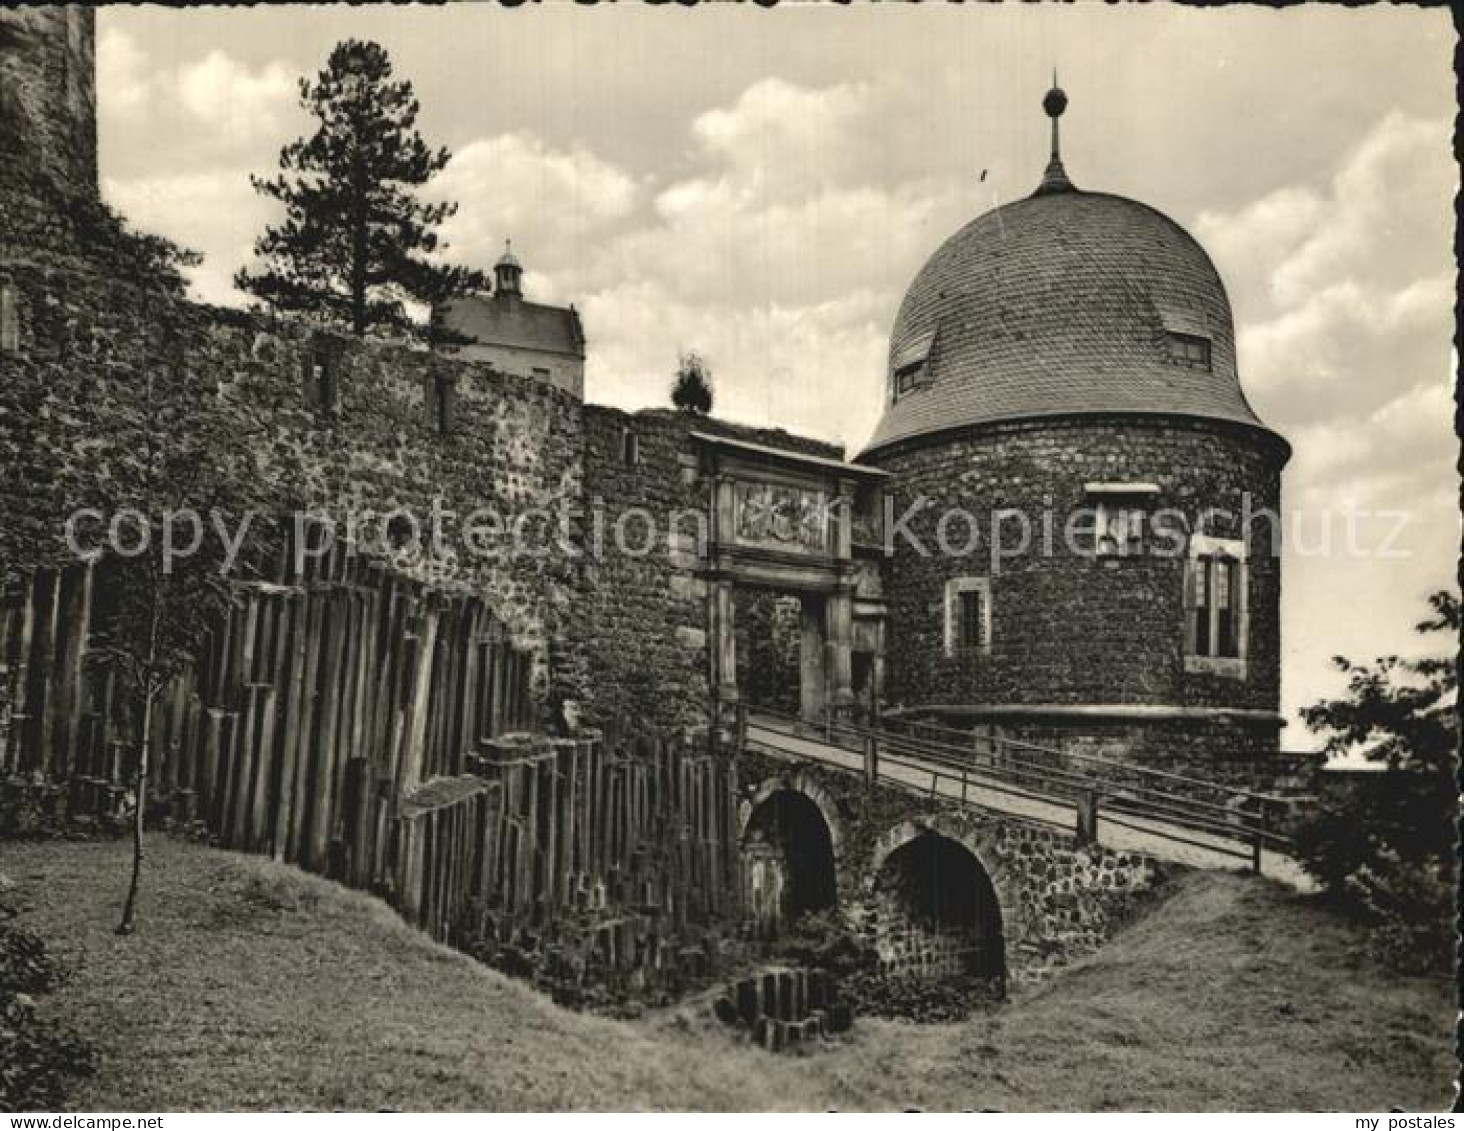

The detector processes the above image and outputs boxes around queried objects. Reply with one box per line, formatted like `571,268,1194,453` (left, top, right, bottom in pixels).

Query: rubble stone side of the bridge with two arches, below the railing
738,745,1173,982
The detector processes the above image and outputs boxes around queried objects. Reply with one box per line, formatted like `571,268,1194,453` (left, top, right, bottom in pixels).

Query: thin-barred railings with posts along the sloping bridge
739,708,1291,871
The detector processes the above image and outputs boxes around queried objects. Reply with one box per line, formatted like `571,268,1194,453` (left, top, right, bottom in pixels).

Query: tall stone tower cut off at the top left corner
0,4,97,196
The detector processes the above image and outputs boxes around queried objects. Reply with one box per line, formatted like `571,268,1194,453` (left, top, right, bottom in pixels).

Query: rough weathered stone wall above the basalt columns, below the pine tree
0,253,581,705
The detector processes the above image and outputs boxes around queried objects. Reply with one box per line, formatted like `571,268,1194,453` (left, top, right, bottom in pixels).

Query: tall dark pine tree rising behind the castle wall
234,40,486,335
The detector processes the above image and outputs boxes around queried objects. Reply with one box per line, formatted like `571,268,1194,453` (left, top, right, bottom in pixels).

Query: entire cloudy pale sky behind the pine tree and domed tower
98,3,1458,748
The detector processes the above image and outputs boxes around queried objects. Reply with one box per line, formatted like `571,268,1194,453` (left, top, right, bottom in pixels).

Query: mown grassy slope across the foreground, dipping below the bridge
0,840,1454,1111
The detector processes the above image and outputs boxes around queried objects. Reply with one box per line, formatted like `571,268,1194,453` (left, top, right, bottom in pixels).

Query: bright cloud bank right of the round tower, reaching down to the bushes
1196,113,1460,722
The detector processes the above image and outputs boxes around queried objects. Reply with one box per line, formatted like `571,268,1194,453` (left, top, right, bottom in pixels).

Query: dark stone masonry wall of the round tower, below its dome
874,418,1284,749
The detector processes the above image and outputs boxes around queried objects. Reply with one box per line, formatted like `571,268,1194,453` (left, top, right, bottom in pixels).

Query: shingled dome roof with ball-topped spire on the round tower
864,83,1282,455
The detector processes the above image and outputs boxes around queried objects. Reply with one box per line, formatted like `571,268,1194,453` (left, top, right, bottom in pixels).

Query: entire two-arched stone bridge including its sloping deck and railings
738,714,1306,980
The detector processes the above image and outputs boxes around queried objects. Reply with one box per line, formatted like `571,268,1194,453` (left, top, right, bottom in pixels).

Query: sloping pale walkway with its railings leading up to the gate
738,708,1313,890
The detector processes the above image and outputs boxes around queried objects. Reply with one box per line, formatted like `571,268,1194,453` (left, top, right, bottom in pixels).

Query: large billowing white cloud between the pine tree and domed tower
418,69,979,446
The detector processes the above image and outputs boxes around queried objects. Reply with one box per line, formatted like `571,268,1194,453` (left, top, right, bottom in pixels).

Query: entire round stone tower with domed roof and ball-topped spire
859,86,1290,771
